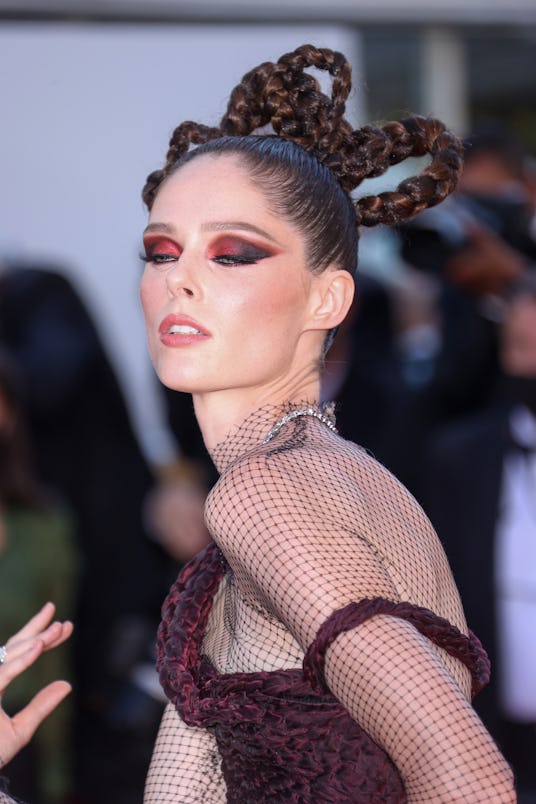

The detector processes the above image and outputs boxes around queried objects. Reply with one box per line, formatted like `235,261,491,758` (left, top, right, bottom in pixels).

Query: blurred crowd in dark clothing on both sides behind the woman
0,124,536,804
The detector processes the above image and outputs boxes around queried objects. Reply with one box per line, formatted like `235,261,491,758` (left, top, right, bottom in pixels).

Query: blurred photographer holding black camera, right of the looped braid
400,123,536,426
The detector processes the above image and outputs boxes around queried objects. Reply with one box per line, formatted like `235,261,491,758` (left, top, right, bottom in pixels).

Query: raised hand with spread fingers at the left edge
0,603,73,768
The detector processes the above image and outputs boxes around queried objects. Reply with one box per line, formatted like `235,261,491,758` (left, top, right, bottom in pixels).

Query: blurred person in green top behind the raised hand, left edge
0,350,78,804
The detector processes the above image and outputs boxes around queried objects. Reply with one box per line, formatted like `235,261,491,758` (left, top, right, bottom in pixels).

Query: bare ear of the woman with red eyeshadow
307,268,355,331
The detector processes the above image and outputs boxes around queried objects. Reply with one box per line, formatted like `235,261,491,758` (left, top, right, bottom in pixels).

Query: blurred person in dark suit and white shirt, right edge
420,276,536,803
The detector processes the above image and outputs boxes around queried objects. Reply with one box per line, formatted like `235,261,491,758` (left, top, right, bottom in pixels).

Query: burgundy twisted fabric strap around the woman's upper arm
303,597,490,696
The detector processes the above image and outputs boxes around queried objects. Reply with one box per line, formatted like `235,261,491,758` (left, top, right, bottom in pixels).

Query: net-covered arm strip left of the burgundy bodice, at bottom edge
143,704,227,804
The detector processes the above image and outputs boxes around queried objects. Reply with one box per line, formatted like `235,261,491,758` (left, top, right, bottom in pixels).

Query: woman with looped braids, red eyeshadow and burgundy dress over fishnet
141,45,514,804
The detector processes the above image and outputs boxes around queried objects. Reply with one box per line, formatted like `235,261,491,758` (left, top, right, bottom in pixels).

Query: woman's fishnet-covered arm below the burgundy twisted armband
325,616,516,804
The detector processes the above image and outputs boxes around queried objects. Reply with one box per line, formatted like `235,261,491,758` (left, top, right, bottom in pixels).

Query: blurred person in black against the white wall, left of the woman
0,264,167,804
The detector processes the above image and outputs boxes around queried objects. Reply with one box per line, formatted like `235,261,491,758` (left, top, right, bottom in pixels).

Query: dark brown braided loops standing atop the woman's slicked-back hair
143,45,461,231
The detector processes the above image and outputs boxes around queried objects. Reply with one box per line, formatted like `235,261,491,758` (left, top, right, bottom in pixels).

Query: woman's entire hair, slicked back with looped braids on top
143,45,462,284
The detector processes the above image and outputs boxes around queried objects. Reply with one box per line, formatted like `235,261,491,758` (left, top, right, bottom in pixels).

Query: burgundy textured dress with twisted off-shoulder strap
158,545,489,804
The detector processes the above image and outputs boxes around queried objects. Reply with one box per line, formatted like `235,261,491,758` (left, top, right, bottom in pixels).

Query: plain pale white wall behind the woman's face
0,23,361,459
